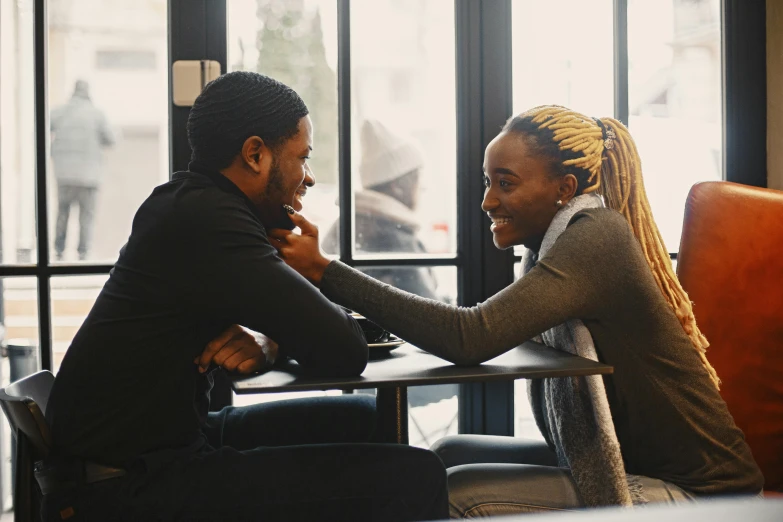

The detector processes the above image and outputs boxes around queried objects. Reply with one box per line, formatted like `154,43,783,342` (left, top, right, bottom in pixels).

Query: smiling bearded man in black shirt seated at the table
43,72,447,521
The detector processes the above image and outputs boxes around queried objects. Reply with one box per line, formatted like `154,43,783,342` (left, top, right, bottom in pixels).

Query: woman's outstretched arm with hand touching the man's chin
270,209,613,365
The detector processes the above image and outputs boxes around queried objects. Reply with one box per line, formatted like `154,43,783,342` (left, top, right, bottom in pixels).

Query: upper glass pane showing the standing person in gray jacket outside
47,0,169,262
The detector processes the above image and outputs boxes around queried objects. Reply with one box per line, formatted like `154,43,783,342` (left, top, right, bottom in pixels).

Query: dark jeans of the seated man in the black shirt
41,395,448,522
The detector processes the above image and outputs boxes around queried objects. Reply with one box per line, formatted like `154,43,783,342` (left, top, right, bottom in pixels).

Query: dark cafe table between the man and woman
232,341,613,444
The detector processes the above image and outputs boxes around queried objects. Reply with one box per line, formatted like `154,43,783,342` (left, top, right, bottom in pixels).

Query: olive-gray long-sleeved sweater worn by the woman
321,208,763,495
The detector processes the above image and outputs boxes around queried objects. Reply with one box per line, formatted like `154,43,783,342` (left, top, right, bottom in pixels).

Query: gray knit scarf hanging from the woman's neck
522,194,645,506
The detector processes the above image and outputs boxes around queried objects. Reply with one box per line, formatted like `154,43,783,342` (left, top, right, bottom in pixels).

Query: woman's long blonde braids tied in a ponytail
504,105,720,387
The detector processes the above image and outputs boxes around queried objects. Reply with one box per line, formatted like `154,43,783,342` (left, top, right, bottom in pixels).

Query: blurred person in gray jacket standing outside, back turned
51,80,114,261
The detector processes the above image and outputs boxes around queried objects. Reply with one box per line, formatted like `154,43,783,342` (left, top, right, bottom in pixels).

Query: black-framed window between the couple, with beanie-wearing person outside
227,0,458,445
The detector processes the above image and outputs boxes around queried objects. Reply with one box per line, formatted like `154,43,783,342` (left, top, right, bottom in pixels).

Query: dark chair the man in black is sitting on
0,370,54,522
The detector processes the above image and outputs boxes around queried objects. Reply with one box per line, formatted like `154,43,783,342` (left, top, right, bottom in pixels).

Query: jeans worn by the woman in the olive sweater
432,435,696,518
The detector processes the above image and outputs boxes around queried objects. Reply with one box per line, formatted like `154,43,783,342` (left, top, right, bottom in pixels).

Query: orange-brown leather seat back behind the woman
677,181,783,492
